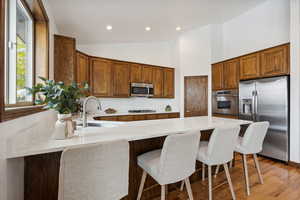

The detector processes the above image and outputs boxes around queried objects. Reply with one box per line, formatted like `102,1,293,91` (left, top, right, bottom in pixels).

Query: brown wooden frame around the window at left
0,0,50,122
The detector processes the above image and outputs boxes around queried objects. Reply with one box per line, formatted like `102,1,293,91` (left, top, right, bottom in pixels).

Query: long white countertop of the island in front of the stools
7,116,251,158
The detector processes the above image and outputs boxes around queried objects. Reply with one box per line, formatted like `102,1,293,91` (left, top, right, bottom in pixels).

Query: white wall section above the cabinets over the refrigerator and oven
213,0,290,62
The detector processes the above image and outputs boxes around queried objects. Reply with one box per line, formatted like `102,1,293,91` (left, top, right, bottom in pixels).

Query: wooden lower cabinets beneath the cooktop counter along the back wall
94,113,180,122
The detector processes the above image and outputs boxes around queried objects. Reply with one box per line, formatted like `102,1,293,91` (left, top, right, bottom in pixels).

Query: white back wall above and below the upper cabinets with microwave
77,42,179,113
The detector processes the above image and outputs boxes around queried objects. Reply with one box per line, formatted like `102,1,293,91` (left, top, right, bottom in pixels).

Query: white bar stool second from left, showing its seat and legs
137,131,200,200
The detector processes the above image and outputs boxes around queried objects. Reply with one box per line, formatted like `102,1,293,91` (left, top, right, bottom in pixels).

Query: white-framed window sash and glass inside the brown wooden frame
5,0,34,106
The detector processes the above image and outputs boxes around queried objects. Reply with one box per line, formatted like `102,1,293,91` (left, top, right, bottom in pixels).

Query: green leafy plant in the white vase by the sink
27,77,89,114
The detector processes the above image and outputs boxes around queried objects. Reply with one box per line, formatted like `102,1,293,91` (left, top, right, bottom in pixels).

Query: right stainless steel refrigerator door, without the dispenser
255,77,289,161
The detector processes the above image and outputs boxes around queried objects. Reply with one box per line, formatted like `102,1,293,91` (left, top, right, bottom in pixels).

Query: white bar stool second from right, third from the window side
197,125,240,200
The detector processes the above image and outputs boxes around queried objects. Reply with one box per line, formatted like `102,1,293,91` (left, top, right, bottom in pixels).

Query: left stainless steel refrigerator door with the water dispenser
239,80,256,121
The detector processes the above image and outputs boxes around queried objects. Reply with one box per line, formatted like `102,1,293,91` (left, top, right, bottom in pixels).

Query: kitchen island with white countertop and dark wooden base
7,116,251,200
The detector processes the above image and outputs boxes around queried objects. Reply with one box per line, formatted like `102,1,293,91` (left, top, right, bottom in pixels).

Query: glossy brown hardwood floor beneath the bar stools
155,156,300,200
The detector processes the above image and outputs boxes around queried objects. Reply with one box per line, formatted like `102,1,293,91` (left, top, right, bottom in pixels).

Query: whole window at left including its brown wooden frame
0,0,49,122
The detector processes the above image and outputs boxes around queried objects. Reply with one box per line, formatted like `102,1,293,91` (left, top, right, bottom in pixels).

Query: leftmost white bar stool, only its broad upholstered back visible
58,140,129,200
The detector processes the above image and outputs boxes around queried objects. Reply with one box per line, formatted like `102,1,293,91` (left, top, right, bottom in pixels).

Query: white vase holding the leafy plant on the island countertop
52,114,72,140
